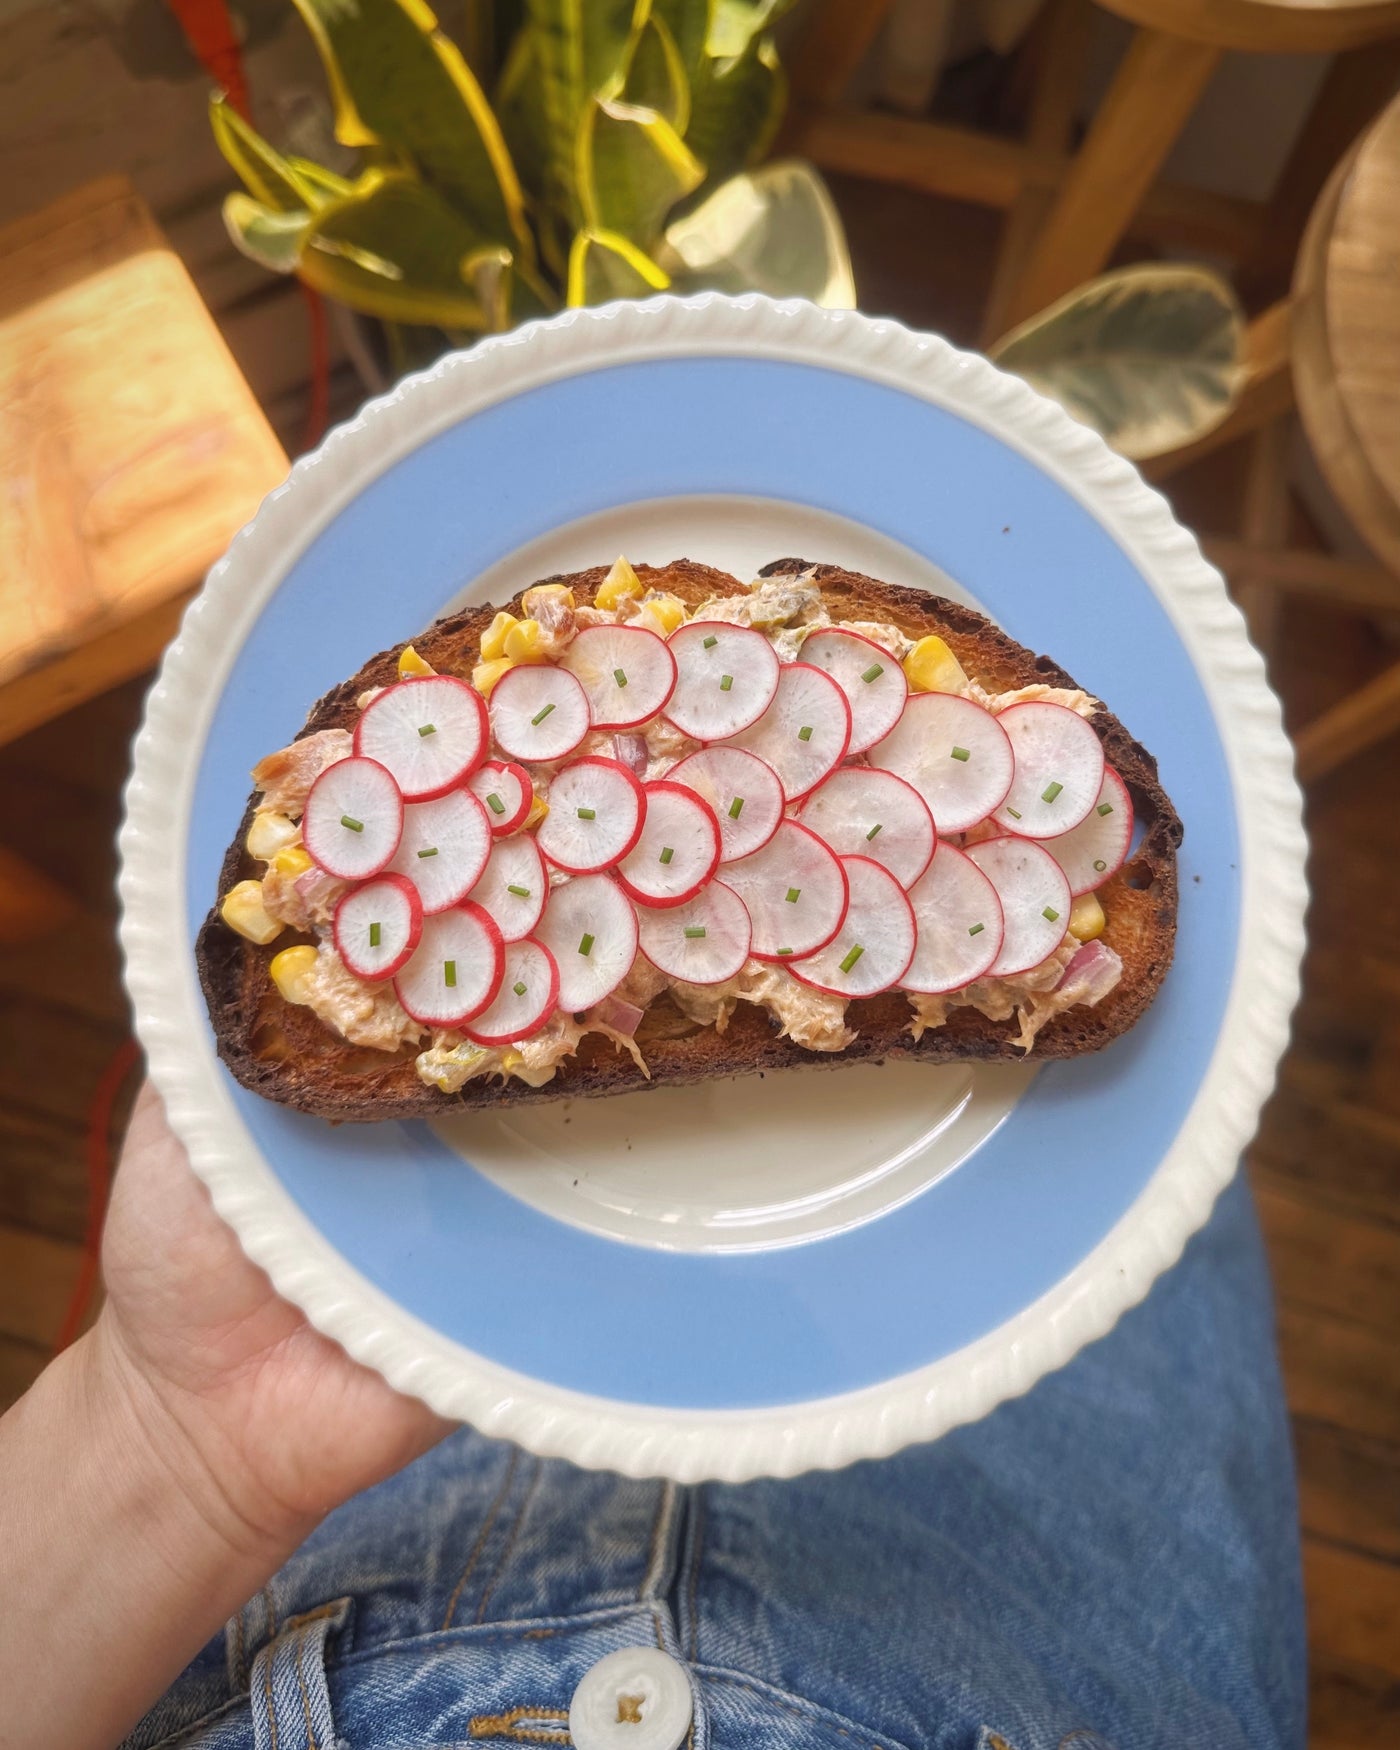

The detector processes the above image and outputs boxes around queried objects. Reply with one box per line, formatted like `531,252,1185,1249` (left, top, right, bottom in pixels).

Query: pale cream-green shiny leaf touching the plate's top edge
660,161,856,310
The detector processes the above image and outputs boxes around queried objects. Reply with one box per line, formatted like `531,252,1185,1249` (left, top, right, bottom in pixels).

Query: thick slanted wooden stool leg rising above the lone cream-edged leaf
1006,30,1222,327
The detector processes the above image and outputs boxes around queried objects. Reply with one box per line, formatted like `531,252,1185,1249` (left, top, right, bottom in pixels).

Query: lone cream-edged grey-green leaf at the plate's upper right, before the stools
991,263,1244,462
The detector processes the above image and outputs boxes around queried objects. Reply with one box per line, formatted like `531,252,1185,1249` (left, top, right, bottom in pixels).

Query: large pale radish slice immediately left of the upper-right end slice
870,693,1015,833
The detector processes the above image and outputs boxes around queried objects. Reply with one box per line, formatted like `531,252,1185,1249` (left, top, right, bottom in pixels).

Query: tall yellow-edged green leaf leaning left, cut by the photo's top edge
294,0,534,259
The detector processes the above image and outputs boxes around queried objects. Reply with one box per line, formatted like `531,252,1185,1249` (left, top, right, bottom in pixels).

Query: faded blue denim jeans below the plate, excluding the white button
128,1183,1306,1750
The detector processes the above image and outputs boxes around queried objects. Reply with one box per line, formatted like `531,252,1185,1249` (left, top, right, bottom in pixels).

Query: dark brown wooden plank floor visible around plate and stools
0,186,1400,1750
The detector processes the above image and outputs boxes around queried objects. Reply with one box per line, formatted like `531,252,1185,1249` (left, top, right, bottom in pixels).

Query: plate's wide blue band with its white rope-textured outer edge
114,298,1302,1475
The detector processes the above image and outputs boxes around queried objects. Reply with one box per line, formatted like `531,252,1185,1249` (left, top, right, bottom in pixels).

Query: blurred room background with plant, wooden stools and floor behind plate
0,0,1400,1750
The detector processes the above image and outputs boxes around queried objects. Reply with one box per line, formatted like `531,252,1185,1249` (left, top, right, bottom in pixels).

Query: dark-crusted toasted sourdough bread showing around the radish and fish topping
196,558,1181,1120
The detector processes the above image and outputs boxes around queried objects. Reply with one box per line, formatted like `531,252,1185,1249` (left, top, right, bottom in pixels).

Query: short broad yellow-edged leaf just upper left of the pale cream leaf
578,100,705,249
